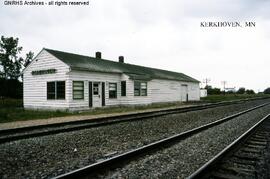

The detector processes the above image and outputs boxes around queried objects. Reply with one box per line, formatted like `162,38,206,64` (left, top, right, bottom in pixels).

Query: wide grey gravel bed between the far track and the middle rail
0,99,270,179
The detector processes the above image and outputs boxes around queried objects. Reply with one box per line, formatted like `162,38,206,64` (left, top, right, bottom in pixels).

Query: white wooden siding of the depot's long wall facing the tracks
66,71,199,109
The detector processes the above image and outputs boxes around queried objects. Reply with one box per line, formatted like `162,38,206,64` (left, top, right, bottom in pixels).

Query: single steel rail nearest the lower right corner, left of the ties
188,114,270,179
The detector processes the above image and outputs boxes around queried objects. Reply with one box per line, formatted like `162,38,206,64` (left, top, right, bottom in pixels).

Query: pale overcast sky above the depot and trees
0,0,270,92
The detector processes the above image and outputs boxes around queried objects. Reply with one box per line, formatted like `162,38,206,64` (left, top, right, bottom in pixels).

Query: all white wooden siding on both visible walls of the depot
23,50,200,110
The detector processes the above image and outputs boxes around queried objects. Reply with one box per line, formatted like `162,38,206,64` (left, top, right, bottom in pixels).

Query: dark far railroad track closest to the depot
0,98,264,143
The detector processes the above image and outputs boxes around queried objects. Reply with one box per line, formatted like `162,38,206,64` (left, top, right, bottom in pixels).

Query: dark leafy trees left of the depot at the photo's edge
0,36,34,98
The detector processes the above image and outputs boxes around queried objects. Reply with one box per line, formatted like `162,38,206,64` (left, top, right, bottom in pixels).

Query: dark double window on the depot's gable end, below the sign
47,81,66,99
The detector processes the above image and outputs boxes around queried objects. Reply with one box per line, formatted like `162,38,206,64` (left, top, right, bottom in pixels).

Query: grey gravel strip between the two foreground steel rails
102,105,270,178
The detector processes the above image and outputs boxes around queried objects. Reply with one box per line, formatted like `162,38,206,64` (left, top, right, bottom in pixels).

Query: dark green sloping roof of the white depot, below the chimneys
44,48,199,83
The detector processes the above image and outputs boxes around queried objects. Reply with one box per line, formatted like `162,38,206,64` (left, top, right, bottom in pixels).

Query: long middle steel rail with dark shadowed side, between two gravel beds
52,103,270,179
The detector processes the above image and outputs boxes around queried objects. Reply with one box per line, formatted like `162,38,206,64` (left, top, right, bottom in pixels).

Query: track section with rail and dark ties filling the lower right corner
188,114,270,179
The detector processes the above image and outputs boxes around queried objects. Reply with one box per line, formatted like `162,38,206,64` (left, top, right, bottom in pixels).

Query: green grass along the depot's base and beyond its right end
0,94,270,123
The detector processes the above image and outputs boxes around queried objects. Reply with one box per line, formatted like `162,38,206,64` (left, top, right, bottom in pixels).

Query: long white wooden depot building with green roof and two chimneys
23,48,200,110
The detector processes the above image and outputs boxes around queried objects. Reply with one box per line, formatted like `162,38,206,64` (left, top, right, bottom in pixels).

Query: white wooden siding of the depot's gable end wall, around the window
23,50,69,109
